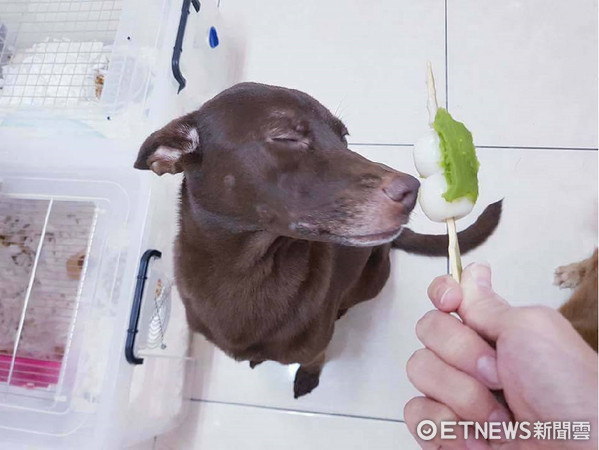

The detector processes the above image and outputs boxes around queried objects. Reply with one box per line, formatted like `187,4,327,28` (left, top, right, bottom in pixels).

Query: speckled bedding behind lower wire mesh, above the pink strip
0,199,94,368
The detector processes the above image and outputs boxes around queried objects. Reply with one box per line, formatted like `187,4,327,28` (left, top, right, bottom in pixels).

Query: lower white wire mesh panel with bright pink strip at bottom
0,198,96,393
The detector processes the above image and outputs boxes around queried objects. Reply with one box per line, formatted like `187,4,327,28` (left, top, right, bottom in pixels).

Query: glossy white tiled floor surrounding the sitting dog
154,0,597,450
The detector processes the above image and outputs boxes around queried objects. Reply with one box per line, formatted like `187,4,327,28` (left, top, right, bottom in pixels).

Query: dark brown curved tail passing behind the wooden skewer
392,200,503,256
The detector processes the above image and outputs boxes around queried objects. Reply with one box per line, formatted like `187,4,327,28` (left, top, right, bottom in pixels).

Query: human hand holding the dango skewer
404,264,597,449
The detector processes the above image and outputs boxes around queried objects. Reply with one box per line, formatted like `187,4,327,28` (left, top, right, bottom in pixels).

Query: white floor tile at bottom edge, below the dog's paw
156,402,418,450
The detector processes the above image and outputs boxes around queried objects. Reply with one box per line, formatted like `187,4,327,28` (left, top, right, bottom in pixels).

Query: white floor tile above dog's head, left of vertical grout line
221,0,445,143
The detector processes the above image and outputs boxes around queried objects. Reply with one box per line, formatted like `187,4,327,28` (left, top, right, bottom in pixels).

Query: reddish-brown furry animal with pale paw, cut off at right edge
555,250,599,351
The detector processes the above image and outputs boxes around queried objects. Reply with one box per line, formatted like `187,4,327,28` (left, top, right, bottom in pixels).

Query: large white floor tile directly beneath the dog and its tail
186,147,597,419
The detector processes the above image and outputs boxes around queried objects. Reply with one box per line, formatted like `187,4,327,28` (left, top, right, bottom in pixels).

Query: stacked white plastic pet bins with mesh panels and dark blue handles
0,0,239,449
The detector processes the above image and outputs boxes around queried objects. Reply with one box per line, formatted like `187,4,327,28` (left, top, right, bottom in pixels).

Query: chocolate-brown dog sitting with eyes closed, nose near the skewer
135,83,501,398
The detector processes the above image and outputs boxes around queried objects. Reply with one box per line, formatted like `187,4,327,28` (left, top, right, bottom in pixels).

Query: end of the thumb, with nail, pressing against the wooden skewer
457,263,511,341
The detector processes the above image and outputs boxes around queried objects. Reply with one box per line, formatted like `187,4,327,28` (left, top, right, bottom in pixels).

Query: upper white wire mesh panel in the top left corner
0,0,123,109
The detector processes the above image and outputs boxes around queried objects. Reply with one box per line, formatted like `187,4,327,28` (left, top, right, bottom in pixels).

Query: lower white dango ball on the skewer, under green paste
418,171,474,222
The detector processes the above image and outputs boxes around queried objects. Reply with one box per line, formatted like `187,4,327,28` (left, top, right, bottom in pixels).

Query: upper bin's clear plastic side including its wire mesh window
0,0,168,121
